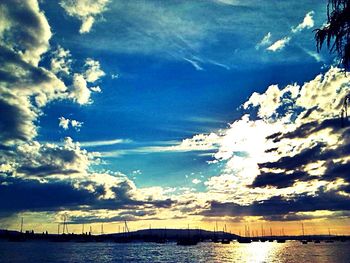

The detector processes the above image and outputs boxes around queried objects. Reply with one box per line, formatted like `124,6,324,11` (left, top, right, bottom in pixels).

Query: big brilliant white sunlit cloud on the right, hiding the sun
170,68,350,205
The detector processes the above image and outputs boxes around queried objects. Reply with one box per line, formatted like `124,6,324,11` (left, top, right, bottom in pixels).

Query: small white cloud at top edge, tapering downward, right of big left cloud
60,0,109,34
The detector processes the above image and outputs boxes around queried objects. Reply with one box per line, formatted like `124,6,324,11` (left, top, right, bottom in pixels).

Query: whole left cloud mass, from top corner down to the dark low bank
0,0,175,225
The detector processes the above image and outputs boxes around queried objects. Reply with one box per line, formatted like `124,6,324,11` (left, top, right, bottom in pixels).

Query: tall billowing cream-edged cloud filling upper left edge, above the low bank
0,0,67,144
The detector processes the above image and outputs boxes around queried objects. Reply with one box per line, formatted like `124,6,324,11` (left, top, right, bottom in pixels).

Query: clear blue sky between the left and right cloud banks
39,1,325,190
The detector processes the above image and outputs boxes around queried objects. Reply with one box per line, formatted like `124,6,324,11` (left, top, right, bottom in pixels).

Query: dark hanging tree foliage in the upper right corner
315,0,350,69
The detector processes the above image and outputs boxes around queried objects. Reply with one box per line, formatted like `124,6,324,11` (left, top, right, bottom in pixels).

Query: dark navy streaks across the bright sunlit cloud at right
250,118,350,192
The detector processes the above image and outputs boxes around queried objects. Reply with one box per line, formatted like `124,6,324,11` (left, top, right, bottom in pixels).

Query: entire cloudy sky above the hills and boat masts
0,0,350,234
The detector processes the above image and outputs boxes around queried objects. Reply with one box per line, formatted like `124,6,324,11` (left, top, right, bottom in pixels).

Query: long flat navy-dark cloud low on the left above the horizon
0,177,175,220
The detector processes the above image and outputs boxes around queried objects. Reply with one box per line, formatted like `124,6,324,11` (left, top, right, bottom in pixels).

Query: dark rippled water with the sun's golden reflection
0,241,350,263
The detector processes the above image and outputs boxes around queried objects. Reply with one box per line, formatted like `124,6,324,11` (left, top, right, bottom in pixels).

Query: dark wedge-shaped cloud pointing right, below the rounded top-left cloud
0,46,65,144
